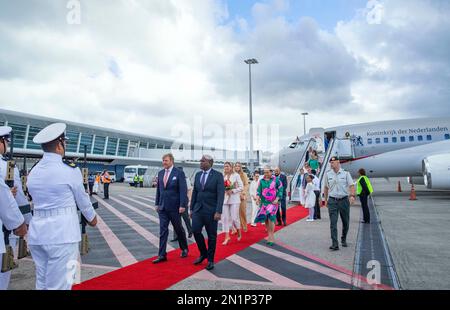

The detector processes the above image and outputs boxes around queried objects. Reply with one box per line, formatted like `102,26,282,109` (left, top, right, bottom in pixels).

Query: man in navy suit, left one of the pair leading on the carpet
153,154,188,264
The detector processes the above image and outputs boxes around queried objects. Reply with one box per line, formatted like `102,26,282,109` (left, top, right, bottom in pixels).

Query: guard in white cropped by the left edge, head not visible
0,179,27,290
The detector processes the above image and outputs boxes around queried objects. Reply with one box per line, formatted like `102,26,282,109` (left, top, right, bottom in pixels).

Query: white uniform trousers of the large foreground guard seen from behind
29,242,80,290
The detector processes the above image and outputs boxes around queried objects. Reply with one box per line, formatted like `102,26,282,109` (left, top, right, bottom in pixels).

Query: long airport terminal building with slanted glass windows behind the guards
0,109,259,180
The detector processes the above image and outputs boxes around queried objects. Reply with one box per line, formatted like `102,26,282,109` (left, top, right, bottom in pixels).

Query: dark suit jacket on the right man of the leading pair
191,169,225,214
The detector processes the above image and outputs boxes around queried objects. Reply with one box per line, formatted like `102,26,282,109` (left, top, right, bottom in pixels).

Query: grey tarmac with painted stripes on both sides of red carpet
10,179,450,290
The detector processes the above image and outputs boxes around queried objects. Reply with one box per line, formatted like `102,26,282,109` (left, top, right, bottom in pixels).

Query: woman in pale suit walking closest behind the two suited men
222,162,244,245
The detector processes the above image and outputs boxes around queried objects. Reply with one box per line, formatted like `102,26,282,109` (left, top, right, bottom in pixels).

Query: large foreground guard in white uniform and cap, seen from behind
27,123,97,290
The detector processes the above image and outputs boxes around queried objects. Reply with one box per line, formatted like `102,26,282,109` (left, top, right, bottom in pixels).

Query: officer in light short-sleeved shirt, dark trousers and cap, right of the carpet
324,156,355,251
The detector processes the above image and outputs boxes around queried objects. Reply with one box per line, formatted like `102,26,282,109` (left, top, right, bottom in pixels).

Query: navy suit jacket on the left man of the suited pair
155,167,188,212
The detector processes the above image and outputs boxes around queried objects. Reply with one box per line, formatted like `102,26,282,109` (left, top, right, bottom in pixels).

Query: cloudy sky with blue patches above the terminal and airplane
0,0,450,151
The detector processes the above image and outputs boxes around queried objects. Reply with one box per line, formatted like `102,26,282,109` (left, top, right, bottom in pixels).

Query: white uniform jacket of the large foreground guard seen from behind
27,153,96,245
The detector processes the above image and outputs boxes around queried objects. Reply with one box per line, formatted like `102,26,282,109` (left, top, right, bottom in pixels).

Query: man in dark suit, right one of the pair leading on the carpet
191,155,225,270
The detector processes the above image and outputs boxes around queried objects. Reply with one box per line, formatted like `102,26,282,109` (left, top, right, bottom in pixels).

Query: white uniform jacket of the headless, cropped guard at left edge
0,179,24,254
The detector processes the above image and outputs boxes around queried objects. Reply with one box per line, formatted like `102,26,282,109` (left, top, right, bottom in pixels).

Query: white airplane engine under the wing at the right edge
422,153,450,189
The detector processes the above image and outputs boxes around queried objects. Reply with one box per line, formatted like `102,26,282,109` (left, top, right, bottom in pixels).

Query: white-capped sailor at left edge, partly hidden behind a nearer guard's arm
0,126,31,289
